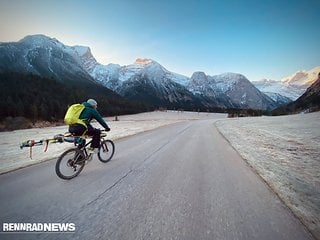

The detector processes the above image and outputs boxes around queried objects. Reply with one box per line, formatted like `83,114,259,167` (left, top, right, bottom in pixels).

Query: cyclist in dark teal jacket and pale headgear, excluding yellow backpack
69,99,110,153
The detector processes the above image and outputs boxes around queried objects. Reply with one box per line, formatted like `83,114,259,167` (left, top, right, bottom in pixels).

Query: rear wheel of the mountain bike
56,148,85,180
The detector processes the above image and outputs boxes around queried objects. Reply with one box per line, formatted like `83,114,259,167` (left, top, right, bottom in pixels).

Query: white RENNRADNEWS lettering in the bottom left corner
2,223,76,233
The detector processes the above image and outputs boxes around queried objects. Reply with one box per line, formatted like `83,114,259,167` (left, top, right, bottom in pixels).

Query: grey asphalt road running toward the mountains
0,120,313,240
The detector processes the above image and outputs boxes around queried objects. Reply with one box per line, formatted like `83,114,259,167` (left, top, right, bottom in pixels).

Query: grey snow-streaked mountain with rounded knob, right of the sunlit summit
188,72,276,110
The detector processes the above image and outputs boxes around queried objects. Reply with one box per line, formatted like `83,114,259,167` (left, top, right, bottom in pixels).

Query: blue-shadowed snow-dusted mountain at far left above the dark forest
0,35,94,82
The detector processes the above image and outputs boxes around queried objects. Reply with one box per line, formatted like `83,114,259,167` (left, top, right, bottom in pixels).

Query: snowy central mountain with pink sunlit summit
110,59,201,109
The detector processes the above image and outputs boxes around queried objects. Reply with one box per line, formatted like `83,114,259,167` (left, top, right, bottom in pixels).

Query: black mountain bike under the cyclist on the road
56,131,115,180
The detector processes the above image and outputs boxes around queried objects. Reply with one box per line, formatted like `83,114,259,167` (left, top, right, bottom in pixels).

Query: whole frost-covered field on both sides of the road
0,111,320,239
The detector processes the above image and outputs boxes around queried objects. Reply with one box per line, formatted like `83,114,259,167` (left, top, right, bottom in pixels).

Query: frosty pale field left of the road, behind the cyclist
0,111,226,174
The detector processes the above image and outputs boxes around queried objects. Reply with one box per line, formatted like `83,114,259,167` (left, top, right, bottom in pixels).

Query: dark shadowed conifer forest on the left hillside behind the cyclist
0,73,149,124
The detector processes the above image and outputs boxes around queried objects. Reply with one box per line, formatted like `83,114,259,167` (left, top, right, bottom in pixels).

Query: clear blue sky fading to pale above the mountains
0,0,320,81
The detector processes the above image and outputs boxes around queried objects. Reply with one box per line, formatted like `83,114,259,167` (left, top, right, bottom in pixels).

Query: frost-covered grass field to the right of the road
216,112,320,239
